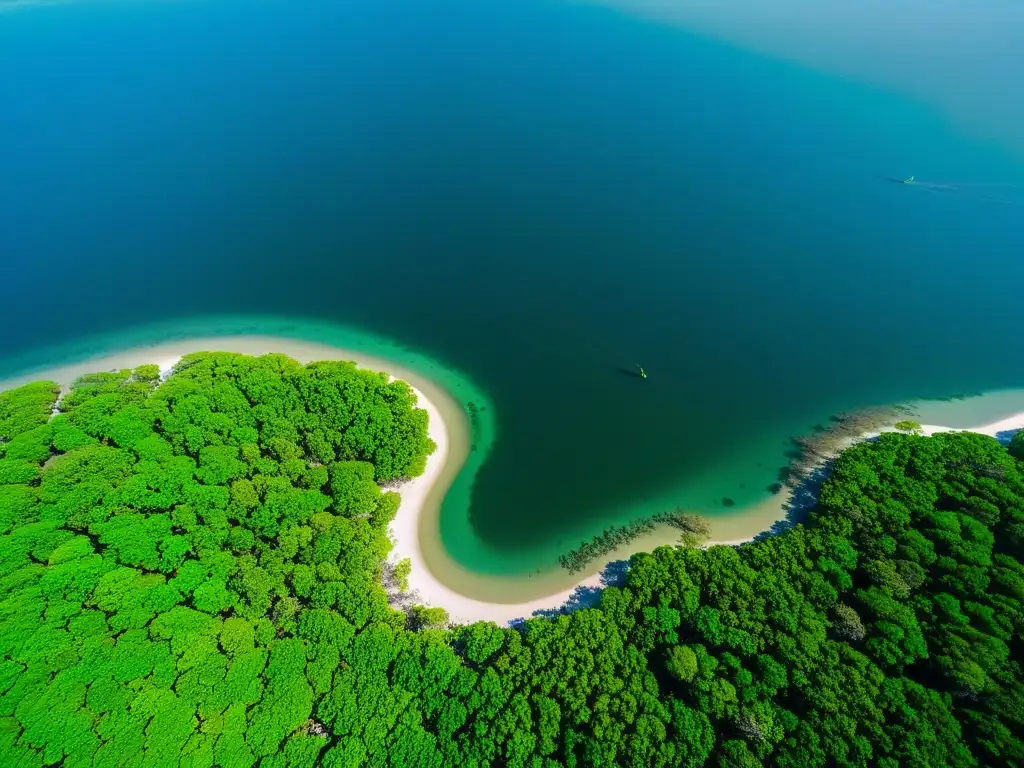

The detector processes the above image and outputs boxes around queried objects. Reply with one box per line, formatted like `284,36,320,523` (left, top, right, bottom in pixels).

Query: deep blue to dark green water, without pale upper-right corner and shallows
0,0,1024,568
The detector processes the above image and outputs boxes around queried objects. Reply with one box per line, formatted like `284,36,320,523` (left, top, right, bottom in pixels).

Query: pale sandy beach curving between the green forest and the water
8,336,1024,625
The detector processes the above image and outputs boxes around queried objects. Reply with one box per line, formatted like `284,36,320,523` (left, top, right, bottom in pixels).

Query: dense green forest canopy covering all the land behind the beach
0,354,1024,768
